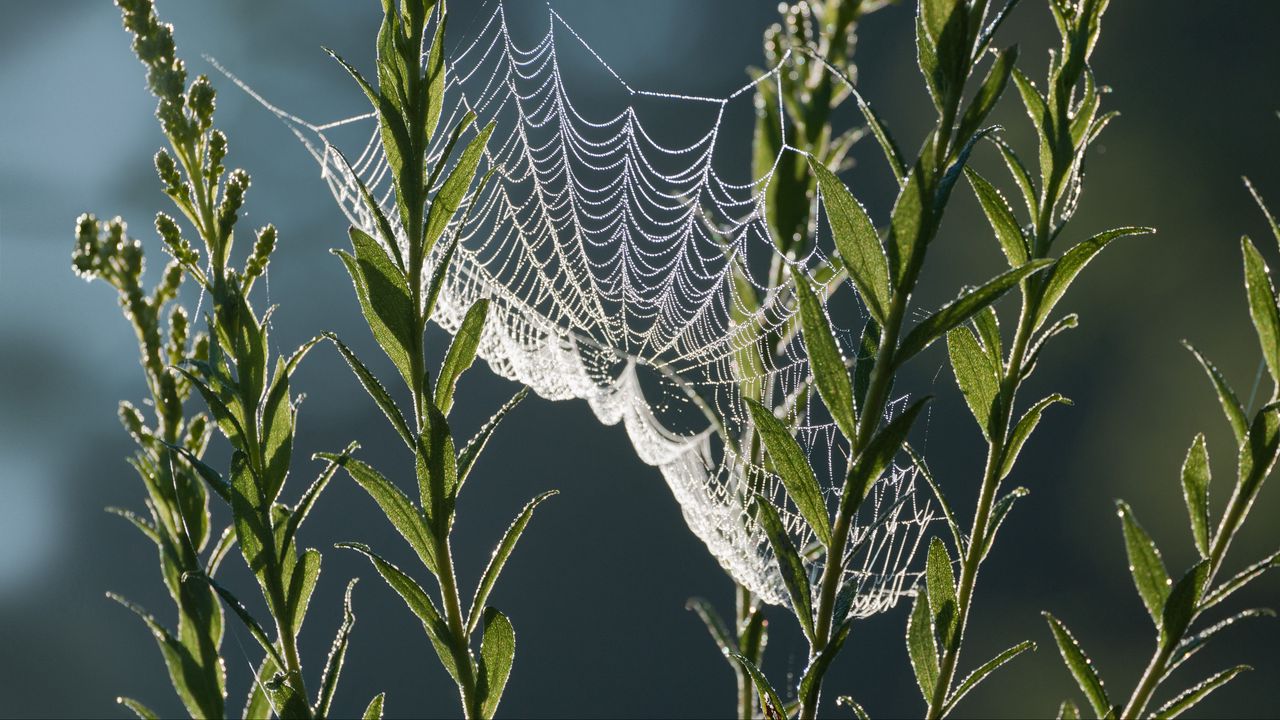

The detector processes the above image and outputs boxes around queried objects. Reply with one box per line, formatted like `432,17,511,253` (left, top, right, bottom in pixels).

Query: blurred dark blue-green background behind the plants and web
0,0,1280,717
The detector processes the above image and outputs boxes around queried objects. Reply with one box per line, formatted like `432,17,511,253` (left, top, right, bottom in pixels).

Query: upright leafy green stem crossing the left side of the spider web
317,0,554,717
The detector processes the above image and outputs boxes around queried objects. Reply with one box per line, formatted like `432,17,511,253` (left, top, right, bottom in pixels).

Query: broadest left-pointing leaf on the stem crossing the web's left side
335,225,415,386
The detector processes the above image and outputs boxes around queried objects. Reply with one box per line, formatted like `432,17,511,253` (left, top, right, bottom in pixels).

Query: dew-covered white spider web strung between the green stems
238,4,932,615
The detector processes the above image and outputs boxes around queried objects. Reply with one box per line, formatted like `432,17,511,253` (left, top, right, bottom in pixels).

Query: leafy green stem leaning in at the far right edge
1044,181,1280,717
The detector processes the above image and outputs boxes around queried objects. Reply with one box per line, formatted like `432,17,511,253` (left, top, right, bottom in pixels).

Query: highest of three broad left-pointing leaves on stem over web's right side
809,159,890,324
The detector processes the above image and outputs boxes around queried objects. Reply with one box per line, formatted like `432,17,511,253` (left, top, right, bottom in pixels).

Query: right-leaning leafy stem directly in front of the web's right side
739,0,1075,717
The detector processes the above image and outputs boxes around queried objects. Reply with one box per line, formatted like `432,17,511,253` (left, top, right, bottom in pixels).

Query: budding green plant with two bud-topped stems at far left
74,0,380,717
